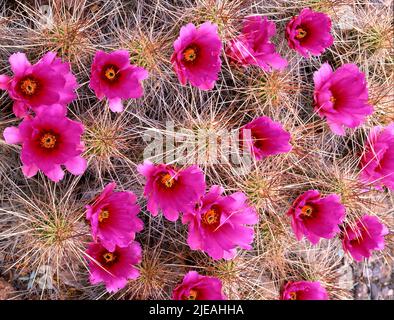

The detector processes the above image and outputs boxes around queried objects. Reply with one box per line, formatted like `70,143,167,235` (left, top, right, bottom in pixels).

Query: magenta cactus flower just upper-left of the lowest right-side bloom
287,190,345,244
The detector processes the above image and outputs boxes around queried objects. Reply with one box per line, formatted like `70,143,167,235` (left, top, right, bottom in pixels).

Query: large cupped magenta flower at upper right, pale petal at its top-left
313,63,373,135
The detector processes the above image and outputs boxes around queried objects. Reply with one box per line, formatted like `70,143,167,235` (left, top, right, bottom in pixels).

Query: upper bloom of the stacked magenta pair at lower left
86,182,144,251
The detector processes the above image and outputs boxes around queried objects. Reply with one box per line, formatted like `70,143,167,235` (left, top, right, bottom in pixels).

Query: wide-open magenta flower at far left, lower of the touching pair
4,105,87,182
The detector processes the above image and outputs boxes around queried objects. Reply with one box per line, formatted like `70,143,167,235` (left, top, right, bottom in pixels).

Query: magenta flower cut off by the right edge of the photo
361,123,394,190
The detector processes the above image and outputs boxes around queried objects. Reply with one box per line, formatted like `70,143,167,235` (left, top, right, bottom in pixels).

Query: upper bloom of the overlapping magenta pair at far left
0,52,78,117
